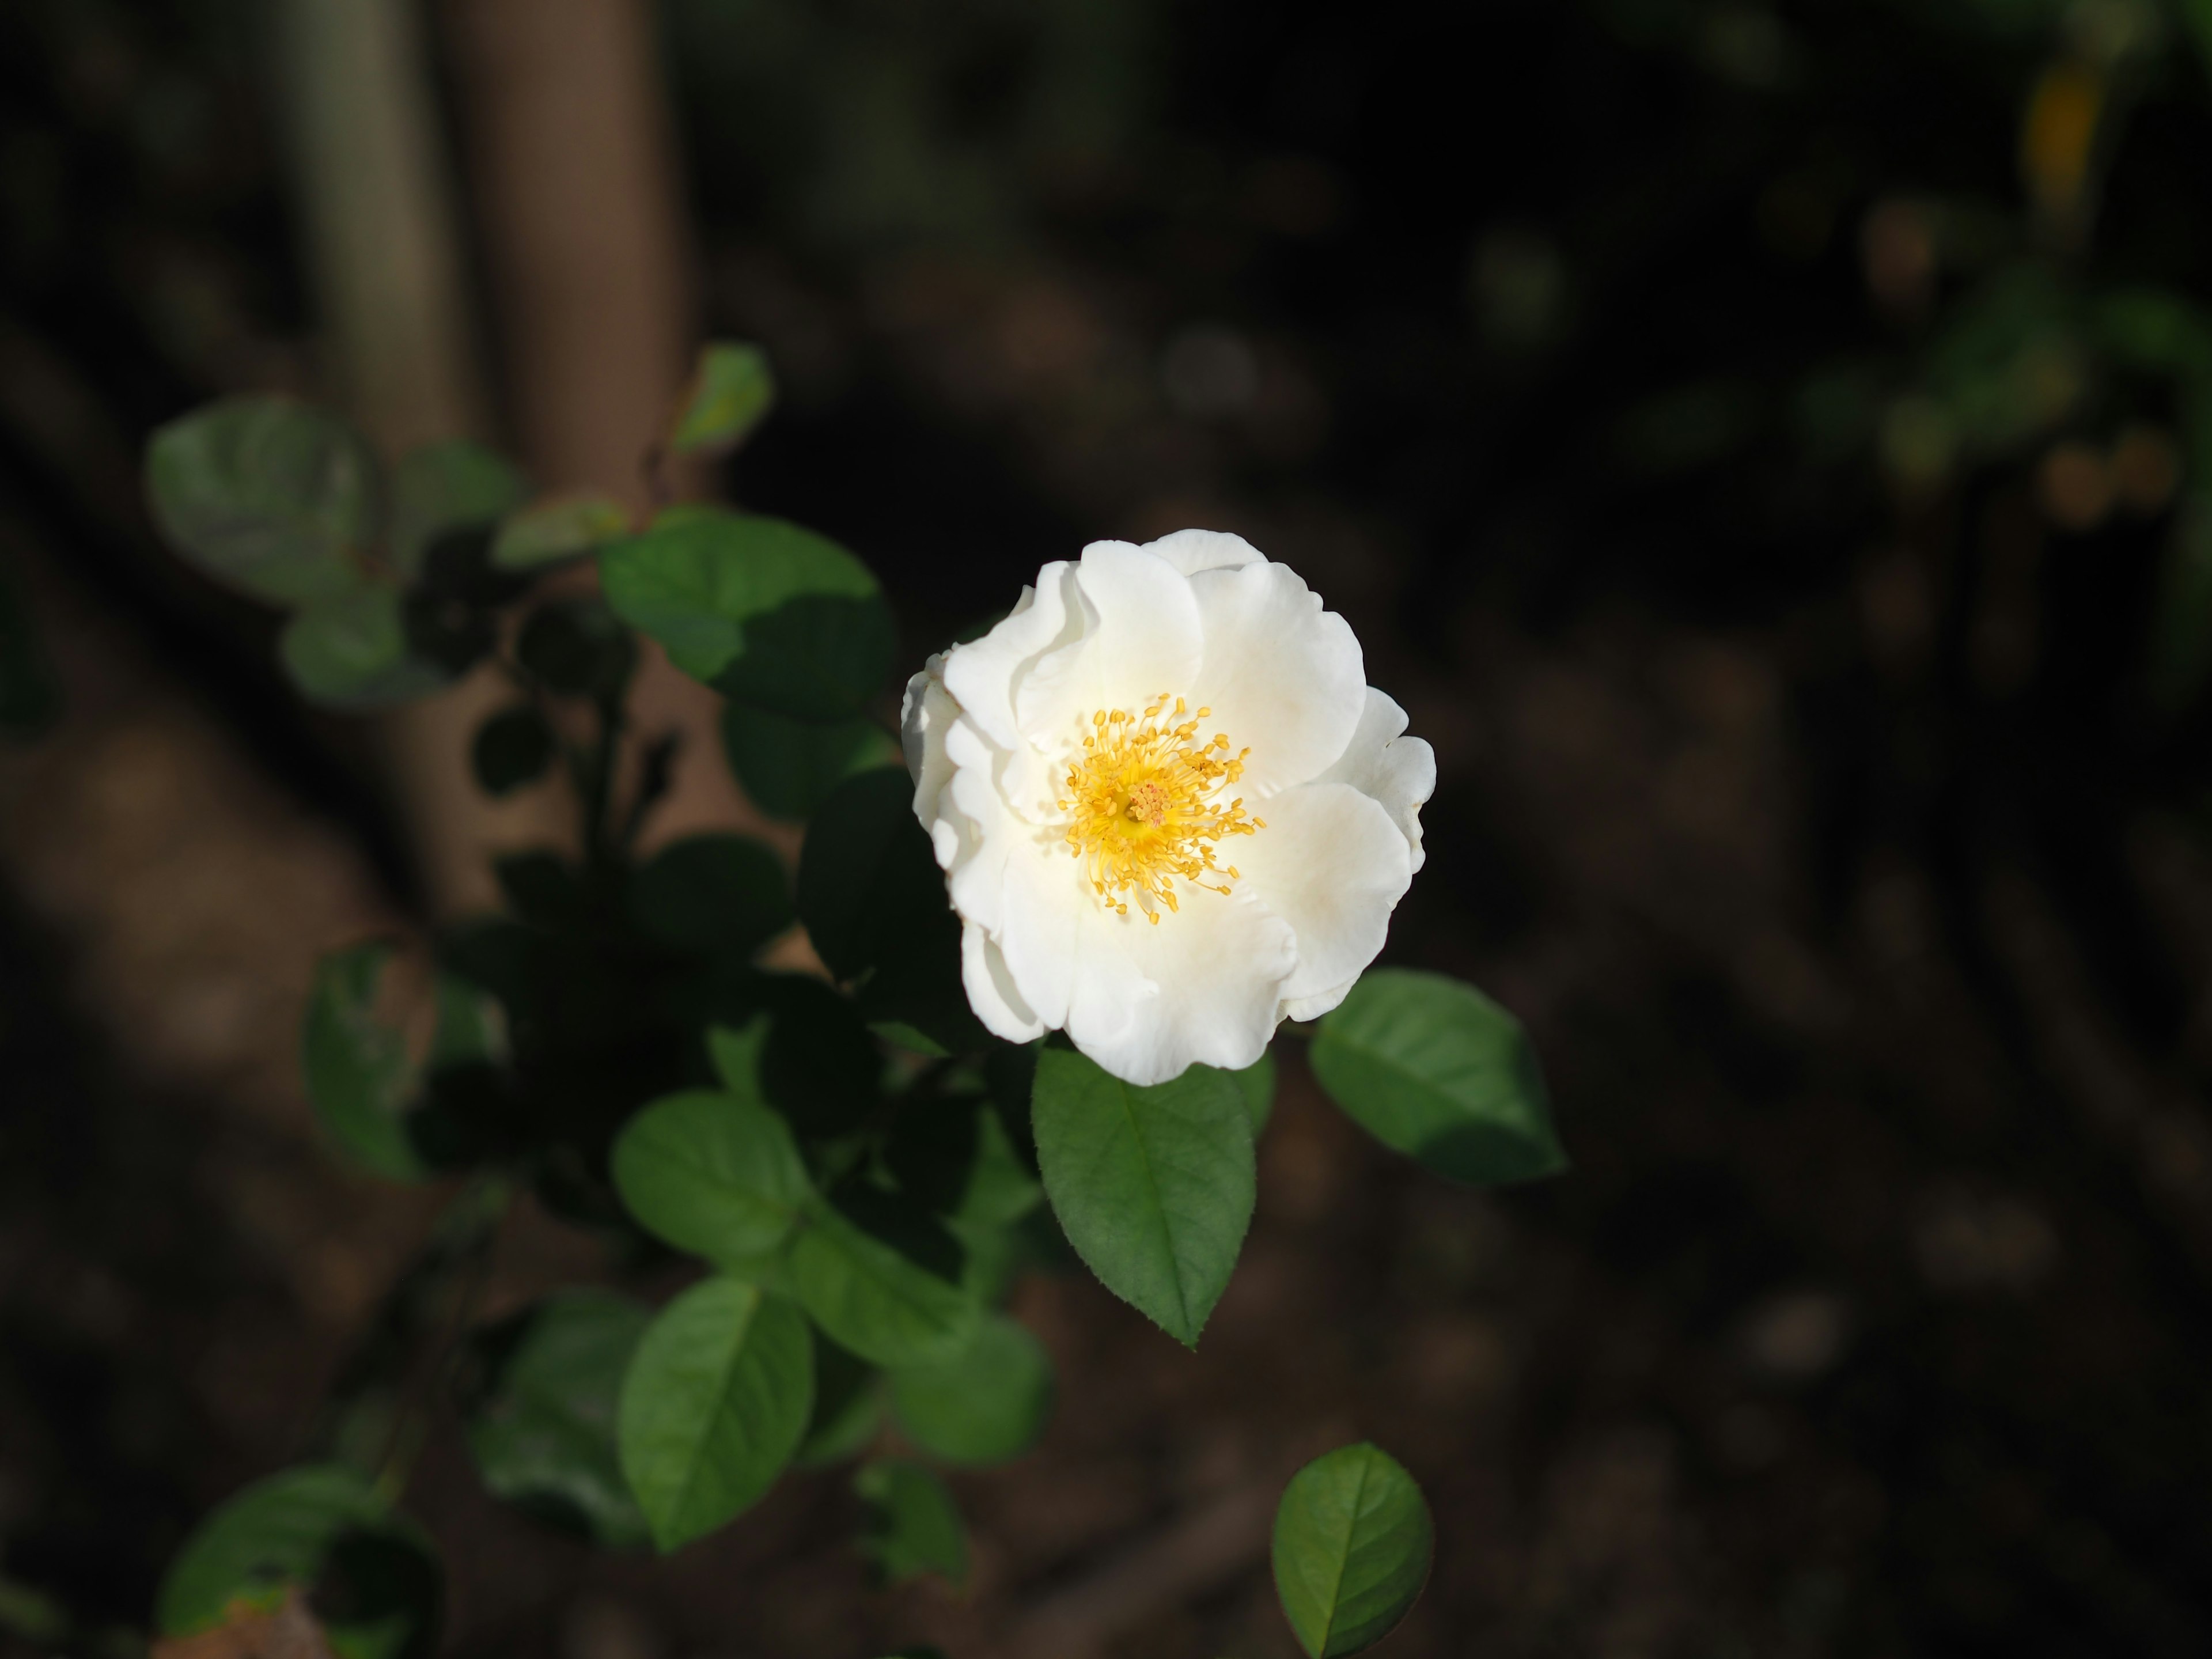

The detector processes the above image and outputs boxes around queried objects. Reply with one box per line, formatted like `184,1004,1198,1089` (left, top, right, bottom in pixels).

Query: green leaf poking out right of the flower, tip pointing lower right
1312,969,1566,1185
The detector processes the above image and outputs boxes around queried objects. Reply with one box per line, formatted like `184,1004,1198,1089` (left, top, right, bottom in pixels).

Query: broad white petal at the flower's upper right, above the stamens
1177,564,1367,796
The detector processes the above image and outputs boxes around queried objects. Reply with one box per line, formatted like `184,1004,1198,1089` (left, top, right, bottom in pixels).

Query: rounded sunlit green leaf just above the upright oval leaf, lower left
611,1090,812,1263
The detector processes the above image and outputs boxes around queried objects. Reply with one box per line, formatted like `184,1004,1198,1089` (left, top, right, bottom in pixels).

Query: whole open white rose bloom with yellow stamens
903,531,1435,1084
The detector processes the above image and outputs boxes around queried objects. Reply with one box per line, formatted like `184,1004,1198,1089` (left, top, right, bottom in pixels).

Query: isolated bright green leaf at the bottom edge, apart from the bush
1274,1442,1435,1659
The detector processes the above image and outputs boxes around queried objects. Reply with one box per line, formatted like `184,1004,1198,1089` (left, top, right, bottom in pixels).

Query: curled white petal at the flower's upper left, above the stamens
1013,542,1203,759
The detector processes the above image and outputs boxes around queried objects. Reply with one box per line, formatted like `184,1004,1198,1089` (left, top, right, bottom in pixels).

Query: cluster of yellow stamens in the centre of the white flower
1059,692,1267,927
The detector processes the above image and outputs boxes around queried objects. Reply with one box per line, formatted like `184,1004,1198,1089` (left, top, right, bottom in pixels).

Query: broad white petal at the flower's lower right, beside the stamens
1221,783,1414,1002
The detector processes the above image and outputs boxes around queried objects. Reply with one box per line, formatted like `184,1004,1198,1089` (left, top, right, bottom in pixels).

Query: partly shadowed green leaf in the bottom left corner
155,1464,440,1659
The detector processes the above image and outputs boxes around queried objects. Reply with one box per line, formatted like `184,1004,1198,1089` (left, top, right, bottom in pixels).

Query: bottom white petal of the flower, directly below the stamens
1066,892,1296,1084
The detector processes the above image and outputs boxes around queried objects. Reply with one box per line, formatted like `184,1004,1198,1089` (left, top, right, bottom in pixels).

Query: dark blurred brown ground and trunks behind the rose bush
0,0,2212,1659
